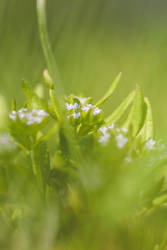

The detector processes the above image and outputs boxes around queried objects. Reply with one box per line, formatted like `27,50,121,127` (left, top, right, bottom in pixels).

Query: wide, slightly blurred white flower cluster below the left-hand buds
9,108,49,125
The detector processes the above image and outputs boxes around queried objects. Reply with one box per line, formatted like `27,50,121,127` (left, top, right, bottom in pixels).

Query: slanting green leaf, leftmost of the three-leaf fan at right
105,91,135,125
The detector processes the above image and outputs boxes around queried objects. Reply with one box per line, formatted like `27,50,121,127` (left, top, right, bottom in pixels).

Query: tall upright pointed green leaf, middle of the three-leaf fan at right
123,85,146,136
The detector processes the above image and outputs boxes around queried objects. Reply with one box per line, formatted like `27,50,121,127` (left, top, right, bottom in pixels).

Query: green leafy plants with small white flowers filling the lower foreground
0,70,167,250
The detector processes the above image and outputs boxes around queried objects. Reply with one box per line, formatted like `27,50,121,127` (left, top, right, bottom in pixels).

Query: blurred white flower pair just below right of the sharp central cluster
99,124,128,148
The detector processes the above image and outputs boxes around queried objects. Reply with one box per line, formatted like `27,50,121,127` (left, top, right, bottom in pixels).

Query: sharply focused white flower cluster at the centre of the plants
65,101,102,119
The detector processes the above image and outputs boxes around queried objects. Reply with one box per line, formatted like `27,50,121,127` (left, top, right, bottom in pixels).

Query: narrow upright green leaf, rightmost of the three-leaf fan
137,97,154,143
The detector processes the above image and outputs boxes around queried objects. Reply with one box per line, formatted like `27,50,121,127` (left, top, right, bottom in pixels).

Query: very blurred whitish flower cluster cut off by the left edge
0,133,16,153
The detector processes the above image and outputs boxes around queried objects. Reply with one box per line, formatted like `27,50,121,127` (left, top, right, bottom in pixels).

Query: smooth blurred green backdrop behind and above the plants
0,0,167,139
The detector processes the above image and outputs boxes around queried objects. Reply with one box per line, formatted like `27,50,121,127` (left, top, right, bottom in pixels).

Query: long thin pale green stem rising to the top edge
37,0,63,94
